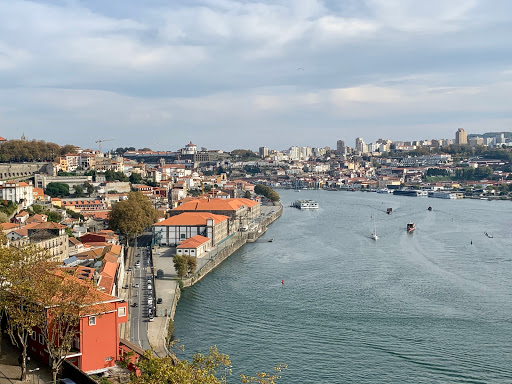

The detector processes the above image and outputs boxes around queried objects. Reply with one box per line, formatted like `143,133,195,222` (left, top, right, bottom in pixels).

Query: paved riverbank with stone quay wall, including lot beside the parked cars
148,202,283,357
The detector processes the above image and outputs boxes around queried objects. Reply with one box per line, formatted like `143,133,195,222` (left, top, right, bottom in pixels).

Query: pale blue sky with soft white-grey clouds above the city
0,0,512,150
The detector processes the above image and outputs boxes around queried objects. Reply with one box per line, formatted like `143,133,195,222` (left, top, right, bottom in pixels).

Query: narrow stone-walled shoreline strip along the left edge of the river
148,201,284,357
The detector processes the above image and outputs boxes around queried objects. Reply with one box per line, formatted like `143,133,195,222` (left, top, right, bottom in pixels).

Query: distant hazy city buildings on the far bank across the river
248,128,512,193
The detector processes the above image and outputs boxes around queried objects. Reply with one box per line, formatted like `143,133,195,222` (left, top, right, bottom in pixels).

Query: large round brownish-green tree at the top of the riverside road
109,192,158,242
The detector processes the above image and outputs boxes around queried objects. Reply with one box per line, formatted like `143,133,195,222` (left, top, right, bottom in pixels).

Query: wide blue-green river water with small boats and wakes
175,190,512,383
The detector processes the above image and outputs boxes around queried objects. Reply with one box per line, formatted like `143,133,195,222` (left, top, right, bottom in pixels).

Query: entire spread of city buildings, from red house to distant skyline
0,128,512,373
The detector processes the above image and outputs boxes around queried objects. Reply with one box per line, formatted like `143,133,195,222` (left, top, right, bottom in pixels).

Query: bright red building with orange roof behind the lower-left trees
28,273,128,374
